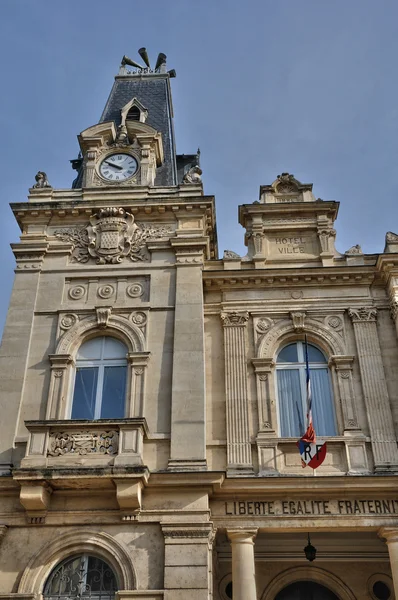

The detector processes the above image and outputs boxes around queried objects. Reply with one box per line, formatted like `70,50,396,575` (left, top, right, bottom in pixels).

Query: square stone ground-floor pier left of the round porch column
162,523,214,600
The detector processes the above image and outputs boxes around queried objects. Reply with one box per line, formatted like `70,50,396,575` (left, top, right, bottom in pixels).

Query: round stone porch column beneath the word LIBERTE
227,529,257,600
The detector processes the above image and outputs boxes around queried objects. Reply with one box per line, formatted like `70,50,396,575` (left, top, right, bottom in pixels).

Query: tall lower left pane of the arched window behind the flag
277,369,304,438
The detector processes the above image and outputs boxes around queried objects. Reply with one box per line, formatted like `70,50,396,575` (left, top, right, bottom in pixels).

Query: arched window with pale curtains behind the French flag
276,342,336,438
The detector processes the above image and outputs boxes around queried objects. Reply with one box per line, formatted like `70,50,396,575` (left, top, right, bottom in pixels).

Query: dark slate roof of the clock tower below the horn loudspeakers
99,76,177,186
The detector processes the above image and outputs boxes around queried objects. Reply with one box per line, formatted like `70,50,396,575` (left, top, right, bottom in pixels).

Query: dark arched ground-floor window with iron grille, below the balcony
43,554,118,600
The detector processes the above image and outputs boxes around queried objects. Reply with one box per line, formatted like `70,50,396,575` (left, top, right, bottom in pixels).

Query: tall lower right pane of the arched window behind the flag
310,369,336,436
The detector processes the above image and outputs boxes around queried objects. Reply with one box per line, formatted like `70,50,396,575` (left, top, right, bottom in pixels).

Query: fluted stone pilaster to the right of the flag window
348,308,398,473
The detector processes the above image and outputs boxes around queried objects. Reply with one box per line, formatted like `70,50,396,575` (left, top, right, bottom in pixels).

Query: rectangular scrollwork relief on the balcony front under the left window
47,430,119,456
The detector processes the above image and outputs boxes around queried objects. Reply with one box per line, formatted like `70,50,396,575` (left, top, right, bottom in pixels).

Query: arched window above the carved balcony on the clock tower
71,337,127,419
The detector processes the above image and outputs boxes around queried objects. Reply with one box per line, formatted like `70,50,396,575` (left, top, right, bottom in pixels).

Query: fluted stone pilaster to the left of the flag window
221,312,253,475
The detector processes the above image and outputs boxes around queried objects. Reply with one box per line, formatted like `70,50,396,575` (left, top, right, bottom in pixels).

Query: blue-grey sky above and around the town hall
0,0,398,336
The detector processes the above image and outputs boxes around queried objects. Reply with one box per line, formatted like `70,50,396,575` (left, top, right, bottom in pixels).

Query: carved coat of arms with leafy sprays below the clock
54,207,170,265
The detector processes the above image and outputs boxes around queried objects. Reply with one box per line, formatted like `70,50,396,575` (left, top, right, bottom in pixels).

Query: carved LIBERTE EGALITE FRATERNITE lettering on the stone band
224,500,398,517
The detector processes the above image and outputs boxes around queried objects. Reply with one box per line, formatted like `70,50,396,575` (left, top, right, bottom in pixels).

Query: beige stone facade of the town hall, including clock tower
0,52,398,600
